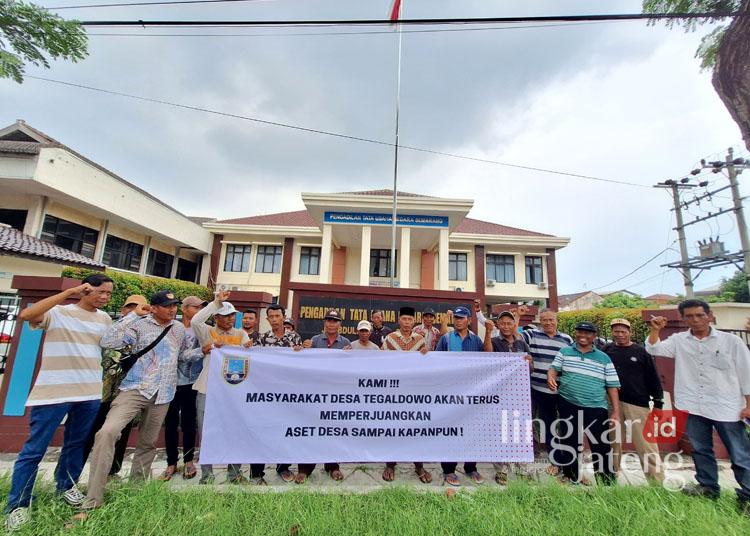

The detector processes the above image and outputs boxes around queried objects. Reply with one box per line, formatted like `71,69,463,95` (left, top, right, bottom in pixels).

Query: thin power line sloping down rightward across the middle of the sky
25,75,650,188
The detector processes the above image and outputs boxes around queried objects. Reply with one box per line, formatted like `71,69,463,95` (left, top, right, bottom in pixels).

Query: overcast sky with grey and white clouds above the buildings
0,0,748,295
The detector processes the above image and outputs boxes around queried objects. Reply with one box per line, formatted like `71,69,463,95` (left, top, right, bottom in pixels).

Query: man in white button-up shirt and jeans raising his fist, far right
646,300,750,515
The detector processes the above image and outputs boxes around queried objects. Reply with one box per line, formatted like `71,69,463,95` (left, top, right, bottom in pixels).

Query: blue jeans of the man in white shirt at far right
686,413,750,501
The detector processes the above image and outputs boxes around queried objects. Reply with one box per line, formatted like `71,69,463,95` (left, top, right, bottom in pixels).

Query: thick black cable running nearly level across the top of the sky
72,12,750,28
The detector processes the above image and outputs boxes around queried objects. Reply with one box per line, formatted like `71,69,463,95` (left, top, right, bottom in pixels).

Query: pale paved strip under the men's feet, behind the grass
0,448,737,493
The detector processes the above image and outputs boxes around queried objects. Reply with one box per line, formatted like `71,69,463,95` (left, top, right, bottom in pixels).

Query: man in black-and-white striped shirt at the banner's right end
521,309,573,475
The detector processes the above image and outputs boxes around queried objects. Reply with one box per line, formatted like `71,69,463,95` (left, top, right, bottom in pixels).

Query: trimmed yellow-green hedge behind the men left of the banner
62,267,213,313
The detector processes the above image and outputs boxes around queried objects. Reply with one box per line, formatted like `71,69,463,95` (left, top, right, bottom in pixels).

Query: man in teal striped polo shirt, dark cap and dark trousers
547,322,620,485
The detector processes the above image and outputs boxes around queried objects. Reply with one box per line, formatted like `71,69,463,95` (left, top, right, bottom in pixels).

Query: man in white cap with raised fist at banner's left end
191,291,258,485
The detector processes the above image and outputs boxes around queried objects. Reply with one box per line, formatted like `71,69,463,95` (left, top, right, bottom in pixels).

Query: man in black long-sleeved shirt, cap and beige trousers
604,318,664,482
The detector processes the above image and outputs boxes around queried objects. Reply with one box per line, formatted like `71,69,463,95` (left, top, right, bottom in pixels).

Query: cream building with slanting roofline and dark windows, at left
0,121,211,293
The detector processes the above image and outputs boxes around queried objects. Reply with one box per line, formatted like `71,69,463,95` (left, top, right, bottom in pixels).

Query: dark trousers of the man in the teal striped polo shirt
551,396,615,484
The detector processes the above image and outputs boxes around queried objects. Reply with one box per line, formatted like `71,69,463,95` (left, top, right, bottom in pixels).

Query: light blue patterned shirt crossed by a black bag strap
100,313,200,404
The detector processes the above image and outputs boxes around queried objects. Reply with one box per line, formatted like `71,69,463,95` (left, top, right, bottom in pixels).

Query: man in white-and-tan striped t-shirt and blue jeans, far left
5,274,112,530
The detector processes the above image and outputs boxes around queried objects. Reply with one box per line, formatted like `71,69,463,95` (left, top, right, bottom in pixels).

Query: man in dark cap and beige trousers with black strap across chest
82,290,203,510
